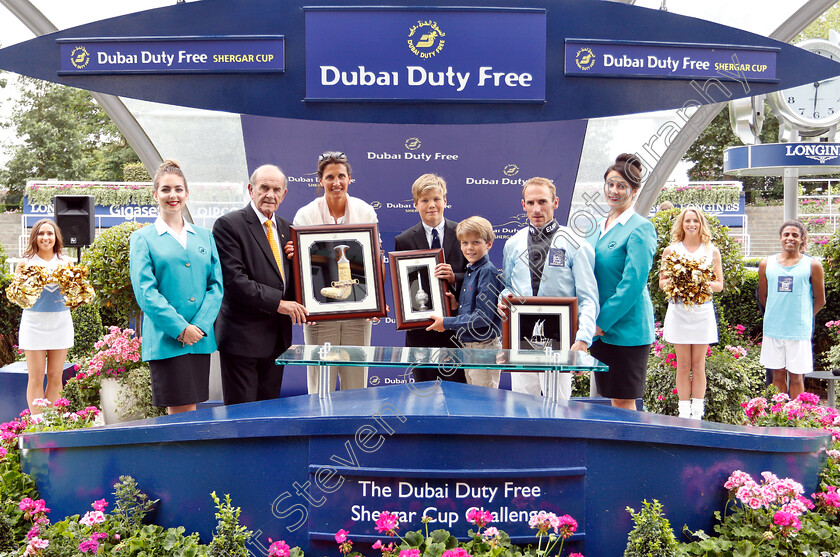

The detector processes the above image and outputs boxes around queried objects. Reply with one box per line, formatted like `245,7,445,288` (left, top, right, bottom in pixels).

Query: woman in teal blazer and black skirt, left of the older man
130,160,222,414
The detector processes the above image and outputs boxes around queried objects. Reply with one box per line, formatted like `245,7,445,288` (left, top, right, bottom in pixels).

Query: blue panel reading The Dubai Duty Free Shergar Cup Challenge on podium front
310,472,586,543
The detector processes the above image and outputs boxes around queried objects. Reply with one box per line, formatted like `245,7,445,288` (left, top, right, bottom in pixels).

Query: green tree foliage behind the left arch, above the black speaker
0,77,138,203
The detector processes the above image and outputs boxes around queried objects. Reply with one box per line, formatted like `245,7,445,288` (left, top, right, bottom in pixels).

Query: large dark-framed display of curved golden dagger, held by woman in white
292,220,386,321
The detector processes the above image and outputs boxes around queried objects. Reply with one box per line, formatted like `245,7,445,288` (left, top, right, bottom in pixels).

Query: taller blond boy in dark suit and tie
394,174,467,383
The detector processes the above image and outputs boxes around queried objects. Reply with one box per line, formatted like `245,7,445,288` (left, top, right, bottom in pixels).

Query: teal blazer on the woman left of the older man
129,225,222,361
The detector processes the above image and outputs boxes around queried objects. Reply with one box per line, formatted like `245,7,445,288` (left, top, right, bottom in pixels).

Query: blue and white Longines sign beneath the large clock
723,142,840,176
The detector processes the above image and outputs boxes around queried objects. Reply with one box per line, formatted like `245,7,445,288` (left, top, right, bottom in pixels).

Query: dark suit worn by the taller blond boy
394,219,467,383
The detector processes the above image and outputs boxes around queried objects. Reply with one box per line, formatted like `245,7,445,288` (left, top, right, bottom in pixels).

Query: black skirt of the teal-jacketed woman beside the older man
149,354,210,406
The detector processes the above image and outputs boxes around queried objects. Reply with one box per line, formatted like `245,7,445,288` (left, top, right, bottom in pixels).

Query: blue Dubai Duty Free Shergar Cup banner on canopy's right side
566,39,779,82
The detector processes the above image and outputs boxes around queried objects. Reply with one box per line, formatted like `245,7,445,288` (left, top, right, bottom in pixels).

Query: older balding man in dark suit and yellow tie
213,165,307,404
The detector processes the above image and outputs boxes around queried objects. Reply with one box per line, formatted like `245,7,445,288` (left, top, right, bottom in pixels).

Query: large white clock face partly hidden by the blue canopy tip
774,39,840,129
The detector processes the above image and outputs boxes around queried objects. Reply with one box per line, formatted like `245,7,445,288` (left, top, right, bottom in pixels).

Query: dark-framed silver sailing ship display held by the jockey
502,296,577,361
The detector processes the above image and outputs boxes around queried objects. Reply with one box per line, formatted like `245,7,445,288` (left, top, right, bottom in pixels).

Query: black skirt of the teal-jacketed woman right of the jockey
589,339,650,399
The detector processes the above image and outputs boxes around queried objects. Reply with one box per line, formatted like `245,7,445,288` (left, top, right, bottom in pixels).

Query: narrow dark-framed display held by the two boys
388,249,452,330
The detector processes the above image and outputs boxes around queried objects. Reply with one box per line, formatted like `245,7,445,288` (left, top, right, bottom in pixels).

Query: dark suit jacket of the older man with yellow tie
213,204,295,358
